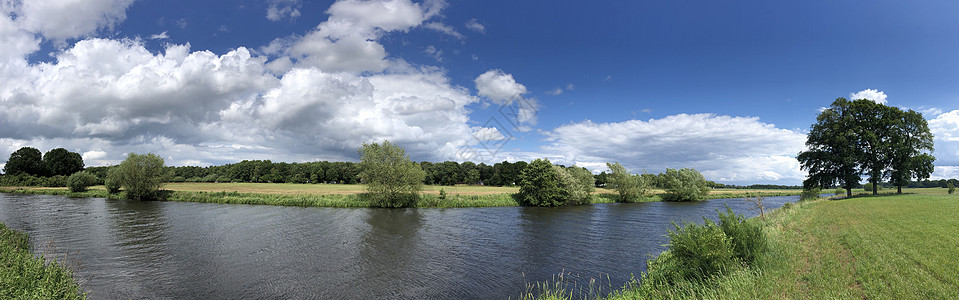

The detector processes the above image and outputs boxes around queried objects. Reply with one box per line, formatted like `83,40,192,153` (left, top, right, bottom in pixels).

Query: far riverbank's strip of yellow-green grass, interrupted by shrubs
0,183,801,208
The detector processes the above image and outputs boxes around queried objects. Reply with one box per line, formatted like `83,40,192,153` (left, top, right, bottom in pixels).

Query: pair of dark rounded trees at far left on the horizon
3,147,83,177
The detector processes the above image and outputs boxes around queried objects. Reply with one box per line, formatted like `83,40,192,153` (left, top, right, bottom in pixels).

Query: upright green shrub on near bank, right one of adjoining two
717,206,768,265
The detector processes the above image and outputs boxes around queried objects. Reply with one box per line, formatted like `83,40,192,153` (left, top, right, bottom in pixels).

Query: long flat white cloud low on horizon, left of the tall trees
544,114,805,184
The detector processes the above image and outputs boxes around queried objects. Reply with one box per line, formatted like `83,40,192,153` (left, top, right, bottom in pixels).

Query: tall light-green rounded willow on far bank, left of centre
359,141,426,207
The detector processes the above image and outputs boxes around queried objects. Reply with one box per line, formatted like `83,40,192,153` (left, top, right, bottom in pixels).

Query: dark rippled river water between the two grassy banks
0,194,798,299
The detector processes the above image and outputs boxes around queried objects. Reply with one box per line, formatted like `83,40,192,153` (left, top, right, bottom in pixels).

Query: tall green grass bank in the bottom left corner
0,223,86,299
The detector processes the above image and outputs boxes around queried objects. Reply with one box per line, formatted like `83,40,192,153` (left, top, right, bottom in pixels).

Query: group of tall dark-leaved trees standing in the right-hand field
797,98,935,196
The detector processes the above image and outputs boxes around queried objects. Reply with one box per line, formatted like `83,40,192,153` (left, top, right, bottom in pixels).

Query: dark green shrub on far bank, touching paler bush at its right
516,159,570,206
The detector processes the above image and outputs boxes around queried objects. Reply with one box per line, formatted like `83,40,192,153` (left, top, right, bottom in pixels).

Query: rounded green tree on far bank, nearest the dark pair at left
117,153,170,200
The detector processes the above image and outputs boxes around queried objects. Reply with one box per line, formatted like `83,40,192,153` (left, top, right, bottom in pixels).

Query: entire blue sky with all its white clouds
0,0,959,185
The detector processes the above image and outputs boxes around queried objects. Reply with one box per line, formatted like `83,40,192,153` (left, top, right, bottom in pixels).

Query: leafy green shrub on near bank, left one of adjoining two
665,218,737,281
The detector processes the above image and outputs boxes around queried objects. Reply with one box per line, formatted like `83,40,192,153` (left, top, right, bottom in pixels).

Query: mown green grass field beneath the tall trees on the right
610,189,959,299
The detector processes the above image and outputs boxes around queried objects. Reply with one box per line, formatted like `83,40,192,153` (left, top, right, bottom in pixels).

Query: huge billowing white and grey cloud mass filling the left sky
0,0,535,166
